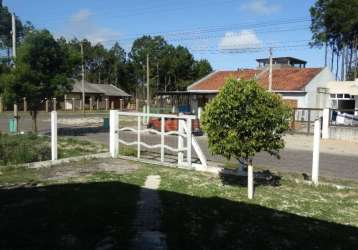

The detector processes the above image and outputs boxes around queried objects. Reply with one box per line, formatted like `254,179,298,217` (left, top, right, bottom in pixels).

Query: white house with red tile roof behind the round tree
187,57,335,114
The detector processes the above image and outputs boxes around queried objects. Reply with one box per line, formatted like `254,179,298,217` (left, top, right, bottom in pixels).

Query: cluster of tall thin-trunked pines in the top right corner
310,0,358,78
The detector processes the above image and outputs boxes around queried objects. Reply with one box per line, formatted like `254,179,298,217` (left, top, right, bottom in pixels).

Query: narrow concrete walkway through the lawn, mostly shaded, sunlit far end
131,175,167,250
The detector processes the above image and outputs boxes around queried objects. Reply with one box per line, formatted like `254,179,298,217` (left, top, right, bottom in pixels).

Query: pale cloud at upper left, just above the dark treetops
62,9,120,45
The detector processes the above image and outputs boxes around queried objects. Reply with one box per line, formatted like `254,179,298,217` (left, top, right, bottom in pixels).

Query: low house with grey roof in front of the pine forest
64,80,130,110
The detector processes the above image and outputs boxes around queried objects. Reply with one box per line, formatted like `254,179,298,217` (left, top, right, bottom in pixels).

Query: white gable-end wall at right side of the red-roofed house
304,67,335,108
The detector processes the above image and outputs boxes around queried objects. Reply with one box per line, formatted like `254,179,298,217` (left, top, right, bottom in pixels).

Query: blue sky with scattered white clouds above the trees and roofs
3,0,324,70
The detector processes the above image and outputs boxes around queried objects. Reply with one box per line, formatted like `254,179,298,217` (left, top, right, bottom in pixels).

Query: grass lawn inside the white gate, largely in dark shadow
0,160,358,249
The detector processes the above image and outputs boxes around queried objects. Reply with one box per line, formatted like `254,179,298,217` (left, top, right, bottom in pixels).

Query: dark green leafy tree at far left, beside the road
1,30,72,132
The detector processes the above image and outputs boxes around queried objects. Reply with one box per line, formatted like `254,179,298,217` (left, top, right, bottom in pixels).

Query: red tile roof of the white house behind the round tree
188,68,322,91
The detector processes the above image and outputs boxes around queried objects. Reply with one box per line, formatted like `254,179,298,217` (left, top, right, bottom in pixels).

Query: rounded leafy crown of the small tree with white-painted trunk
202,79,290,161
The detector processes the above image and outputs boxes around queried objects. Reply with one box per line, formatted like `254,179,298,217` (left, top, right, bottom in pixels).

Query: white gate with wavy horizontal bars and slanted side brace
109,110,207,168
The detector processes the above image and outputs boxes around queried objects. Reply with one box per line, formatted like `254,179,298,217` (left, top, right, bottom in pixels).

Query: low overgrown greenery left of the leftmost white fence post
0,134,51,165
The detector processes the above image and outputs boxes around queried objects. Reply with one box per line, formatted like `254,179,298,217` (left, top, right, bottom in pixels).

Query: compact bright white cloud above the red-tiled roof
219,30,262,51
